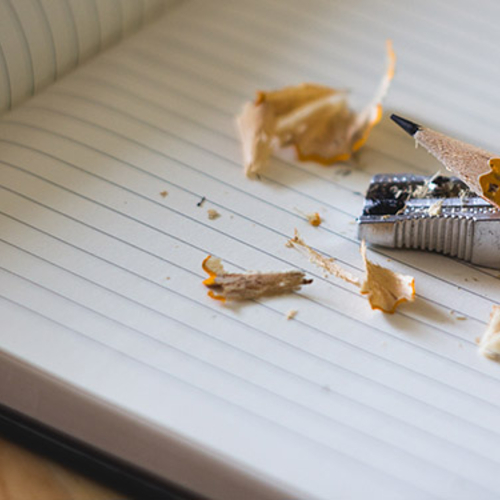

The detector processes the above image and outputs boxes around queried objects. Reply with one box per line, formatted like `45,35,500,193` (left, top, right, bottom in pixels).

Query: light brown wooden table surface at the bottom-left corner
0,438,126,500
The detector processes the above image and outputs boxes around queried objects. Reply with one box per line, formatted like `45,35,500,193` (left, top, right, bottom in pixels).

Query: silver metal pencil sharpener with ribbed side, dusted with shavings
358,174,500,269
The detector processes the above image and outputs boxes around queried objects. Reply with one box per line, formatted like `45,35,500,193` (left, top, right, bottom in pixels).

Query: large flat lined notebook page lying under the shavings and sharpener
0,0,500,500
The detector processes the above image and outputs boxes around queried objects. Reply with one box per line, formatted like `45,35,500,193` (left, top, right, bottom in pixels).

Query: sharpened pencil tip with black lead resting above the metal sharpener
391,115,500,208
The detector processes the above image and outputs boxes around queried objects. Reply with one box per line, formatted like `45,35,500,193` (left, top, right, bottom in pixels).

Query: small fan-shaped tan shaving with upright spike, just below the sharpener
360,241,415,314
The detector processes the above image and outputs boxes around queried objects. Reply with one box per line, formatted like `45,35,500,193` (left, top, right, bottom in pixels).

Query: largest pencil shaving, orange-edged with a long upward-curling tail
237,41,396,176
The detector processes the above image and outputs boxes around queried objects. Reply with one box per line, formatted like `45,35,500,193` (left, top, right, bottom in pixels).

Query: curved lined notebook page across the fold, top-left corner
0,0,170,113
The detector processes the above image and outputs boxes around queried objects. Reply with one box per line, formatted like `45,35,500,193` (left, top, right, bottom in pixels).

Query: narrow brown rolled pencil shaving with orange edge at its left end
202,256,312,302
